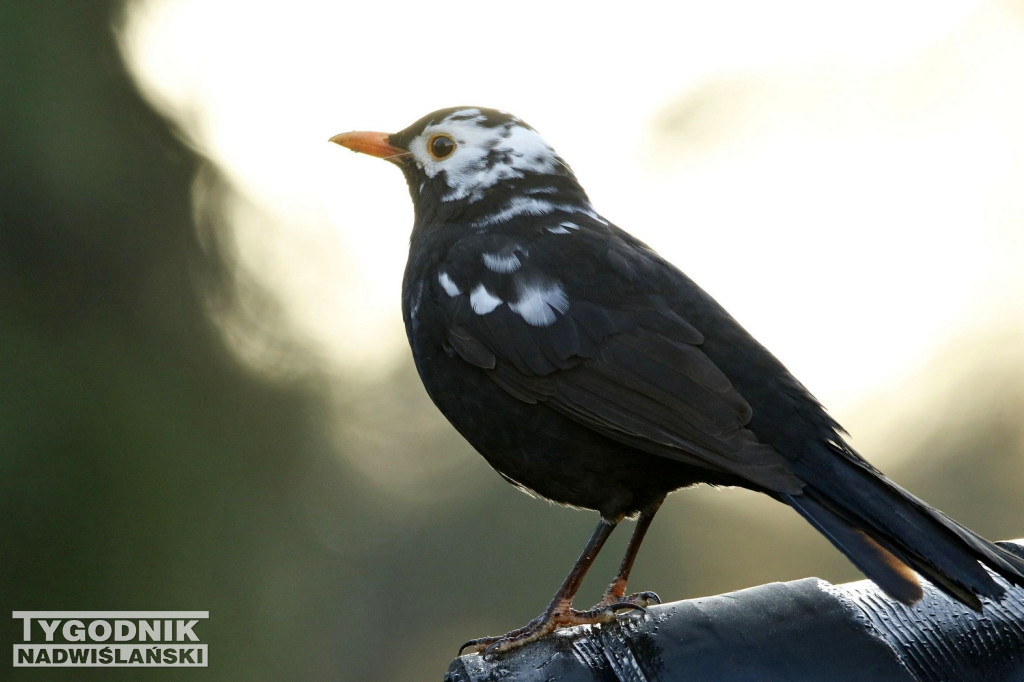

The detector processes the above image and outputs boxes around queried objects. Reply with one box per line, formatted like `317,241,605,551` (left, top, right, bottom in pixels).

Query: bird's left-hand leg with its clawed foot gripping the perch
459,516,618,655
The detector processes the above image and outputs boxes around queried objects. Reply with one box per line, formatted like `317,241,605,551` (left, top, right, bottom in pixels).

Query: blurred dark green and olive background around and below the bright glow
6,0,1024,680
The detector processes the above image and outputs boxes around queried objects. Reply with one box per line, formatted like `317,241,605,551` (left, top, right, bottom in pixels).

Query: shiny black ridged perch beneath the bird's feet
445,540,1024,682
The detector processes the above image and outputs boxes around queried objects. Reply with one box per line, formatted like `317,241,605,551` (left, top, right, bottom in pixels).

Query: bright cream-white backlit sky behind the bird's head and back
124,0,1024,406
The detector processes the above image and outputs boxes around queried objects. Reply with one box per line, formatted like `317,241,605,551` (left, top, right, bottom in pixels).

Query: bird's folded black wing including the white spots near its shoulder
434,225,803,493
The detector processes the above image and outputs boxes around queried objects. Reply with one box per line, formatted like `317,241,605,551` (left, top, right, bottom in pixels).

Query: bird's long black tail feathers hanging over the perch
778,447,1024,611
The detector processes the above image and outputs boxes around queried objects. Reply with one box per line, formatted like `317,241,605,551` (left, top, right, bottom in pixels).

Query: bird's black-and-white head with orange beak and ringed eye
331,106,589,223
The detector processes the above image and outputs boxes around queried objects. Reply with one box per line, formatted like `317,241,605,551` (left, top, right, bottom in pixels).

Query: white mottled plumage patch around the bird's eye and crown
409,109,558,202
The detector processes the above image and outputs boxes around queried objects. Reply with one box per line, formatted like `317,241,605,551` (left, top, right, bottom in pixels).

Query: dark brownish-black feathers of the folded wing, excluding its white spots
439,225,803,493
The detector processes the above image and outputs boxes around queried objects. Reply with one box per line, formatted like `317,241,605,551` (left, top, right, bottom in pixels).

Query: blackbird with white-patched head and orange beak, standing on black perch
330,106,1024,656
